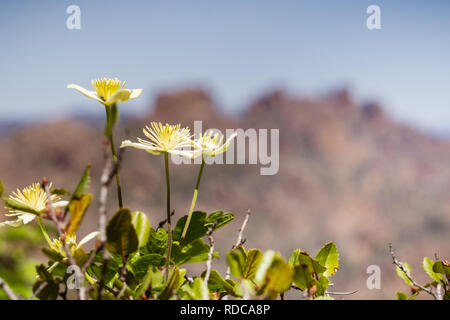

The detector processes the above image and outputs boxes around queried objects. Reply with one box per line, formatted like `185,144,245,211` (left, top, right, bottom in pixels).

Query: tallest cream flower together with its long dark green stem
67,78,142,208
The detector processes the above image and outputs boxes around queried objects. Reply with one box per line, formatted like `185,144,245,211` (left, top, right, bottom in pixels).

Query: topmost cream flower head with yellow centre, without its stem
67,78,142,106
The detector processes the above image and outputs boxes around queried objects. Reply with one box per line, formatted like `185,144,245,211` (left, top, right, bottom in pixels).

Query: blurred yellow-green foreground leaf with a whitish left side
255,250,294,294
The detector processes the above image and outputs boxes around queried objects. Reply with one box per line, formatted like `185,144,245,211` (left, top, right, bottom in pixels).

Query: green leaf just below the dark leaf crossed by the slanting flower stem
171,239,219,266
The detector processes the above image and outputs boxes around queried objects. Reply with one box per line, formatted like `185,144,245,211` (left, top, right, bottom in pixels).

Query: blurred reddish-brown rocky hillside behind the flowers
0,90,450,298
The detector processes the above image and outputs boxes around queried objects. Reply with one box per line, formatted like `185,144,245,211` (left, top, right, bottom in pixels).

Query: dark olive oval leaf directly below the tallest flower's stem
106,208,139,257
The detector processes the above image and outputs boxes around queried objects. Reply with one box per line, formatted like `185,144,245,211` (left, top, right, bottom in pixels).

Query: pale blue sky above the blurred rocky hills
0,0,450,133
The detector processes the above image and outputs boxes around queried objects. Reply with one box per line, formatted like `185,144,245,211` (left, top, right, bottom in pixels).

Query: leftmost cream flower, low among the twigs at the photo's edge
0,183,68,228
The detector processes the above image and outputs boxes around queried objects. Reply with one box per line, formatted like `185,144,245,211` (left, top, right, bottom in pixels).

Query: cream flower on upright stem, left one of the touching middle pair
120,122,194,158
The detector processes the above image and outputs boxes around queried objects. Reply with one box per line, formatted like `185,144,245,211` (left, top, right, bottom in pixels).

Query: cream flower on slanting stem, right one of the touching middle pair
192,130,237,157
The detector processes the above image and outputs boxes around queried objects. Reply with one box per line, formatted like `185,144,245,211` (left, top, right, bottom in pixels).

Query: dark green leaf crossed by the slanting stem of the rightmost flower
172,211,208,246
